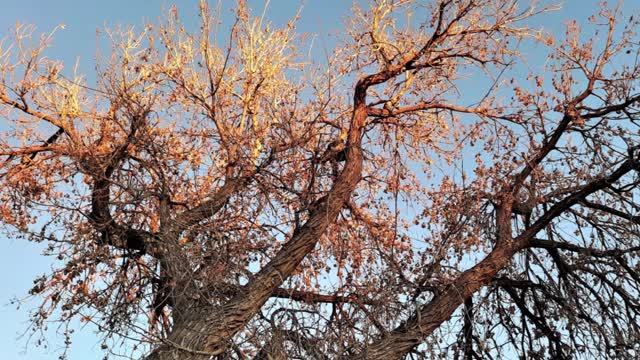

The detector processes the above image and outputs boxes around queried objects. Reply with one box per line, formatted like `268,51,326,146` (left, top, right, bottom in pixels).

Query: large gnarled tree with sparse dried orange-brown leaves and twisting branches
0,0,640,360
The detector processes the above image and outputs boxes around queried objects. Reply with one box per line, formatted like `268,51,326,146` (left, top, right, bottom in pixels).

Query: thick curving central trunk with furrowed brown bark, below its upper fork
142,100,367,360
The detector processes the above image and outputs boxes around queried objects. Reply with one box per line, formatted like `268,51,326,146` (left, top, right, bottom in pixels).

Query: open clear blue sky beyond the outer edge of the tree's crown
0,0,640,360
